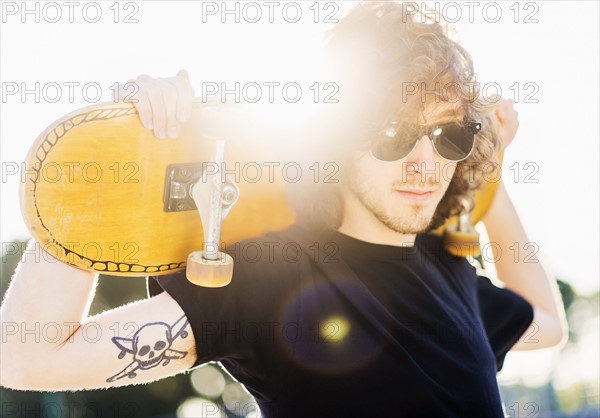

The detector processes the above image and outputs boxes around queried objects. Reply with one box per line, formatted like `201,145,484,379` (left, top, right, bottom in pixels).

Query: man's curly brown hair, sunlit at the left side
294,1,499,230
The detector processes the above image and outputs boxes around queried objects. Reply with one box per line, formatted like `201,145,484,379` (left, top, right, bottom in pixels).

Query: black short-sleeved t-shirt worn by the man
149,225,533,418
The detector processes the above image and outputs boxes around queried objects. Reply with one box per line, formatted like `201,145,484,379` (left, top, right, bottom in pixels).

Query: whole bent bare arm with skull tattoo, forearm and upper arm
0,243,196,391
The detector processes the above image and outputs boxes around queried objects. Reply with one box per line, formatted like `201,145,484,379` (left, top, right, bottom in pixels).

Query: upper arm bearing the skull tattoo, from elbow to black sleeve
17,292,196,390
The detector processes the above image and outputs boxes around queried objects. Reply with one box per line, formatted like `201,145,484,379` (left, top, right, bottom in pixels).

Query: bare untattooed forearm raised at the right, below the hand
483,183,567,348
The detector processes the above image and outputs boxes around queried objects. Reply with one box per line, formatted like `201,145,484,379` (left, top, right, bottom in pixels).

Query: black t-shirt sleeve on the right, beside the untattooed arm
477,276,533,371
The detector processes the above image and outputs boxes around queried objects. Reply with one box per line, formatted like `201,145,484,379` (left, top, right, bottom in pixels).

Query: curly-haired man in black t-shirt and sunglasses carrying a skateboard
0,2,566,417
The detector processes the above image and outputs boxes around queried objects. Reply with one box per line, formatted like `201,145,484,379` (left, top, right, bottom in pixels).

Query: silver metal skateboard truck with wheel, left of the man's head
186,140,239,287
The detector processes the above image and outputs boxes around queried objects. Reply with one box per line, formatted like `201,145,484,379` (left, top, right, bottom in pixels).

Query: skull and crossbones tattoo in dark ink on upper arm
106,315,188,382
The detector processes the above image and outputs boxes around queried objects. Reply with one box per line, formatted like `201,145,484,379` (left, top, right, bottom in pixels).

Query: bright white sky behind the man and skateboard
0,1,599,293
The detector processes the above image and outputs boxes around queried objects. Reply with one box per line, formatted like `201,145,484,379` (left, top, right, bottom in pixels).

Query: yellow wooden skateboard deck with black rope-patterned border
21,102,294,276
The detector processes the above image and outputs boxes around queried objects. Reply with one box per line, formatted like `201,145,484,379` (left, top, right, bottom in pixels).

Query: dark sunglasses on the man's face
371,121,481,162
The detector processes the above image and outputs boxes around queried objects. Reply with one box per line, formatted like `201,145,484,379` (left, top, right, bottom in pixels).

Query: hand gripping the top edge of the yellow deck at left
115,70,194,138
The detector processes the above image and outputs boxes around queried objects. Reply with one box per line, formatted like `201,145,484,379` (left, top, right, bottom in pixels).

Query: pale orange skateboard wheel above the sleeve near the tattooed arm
185,251,233,287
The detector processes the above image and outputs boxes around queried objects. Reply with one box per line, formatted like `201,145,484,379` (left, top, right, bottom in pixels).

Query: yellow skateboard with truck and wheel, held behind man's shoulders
20,99,495,287
